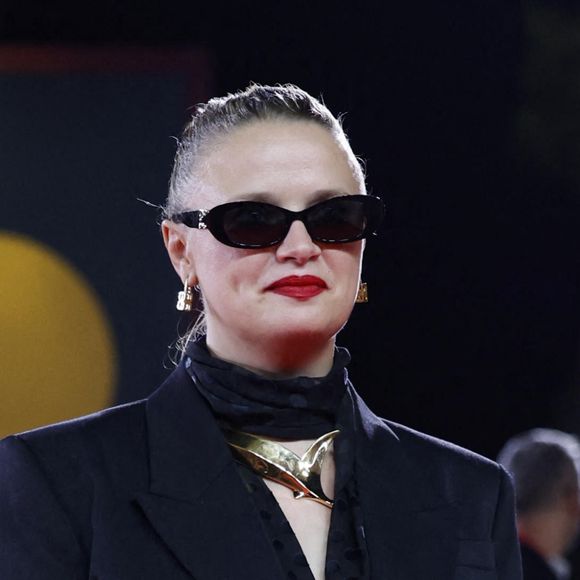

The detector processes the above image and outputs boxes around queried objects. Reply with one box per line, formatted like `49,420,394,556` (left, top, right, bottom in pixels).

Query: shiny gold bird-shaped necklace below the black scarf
224,429,340,508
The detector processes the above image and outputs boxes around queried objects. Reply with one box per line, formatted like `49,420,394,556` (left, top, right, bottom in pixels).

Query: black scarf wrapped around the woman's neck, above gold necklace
185,338,352,439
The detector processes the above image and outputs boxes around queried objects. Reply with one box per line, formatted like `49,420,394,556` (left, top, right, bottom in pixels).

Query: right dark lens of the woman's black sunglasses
308,196,368,242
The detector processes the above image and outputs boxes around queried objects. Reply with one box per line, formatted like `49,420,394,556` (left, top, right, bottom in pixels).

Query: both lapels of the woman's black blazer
136,365,457,580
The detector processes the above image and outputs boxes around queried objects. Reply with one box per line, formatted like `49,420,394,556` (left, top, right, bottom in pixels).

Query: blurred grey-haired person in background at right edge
498,429,580,580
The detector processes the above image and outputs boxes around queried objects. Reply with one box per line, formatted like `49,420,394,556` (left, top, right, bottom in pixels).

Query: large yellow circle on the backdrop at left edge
0,233,116,437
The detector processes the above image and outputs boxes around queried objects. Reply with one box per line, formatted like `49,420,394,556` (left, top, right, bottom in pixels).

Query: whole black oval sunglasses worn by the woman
169,195,384,248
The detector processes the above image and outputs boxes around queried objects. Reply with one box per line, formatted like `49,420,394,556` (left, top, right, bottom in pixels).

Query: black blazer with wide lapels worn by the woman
0,366,521,580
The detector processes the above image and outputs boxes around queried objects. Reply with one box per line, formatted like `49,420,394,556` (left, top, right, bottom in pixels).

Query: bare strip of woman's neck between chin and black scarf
206,329,334,379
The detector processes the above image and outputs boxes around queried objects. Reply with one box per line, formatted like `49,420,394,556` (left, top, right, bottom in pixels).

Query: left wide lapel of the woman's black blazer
135,365,279,580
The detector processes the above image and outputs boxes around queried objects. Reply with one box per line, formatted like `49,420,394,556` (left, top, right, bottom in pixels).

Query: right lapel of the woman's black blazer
354,395,458,580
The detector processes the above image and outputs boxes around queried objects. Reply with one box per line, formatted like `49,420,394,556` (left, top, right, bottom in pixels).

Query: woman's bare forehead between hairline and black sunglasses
198,120,363,208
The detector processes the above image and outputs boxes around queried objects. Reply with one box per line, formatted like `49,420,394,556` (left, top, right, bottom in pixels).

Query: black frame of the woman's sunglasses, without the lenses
169,195,385,249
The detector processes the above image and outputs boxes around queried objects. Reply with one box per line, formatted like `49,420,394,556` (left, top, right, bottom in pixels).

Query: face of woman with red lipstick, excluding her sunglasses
164,120,364,368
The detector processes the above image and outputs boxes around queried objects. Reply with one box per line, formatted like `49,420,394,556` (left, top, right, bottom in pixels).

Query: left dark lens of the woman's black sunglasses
223,202,285,248
